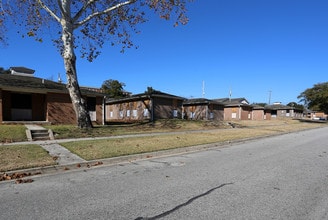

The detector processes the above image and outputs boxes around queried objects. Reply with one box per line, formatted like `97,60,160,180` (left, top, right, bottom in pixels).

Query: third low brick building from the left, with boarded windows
182,98,224,121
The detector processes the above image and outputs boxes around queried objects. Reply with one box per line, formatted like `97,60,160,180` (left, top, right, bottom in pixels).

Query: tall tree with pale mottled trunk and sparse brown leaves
0,0,192,128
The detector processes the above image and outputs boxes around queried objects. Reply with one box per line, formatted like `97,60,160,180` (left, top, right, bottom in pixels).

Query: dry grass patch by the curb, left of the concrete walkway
0,145,56,172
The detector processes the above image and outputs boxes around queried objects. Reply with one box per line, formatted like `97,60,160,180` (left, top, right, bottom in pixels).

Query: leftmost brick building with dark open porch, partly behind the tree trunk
0,67,104,124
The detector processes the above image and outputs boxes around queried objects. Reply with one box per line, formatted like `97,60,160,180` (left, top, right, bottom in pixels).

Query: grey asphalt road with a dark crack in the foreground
0,127,328,220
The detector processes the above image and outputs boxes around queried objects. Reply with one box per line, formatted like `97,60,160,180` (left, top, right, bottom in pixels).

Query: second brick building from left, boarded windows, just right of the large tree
105,90,184,123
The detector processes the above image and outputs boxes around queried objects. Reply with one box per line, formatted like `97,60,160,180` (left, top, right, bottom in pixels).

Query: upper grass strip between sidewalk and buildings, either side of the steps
0,119,218,143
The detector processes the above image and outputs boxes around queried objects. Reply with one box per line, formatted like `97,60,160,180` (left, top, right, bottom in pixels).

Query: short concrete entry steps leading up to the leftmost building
25,125,54,141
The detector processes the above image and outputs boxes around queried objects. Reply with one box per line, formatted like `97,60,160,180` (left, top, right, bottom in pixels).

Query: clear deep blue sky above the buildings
0,0,328,104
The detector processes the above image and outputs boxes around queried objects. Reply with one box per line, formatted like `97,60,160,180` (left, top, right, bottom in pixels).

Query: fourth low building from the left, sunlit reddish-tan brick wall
214,98,252,121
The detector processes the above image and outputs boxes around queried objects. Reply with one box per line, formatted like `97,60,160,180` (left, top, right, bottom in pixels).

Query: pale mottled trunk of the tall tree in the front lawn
62,22,92,129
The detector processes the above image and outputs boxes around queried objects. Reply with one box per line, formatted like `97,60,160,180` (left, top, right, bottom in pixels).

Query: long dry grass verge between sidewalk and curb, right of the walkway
62,120,326,160
